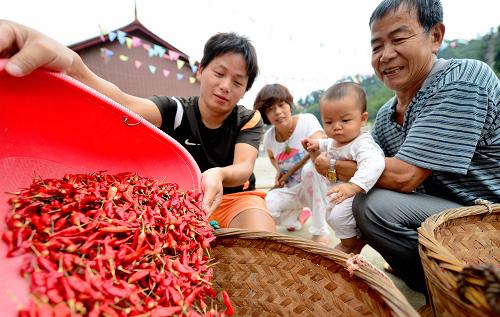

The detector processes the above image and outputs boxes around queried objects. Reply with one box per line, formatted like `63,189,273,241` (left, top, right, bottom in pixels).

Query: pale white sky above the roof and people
0,0,500,107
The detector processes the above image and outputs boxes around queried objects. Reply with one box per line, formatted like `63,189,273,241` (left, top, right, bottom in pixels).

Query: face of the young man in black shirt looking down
196,53,248,116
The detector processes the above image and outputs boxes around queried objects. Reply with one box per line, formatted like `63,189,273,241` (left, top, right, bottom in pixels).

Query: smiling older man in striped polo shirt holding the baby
315,0,500,293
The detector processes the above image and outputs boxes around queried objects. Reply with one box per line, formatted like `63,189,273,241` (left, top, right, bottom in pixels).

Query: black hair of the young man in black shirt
200,32,259,91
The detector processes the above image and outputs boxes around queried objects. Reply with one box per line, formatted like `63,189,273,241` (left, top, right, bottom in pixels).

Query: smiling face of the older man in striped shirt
371,7,441,97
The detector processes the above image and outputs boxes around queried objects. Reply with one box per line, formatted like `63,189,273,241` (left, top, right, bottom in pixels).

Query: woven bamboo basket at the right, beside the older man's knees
418,204,500,317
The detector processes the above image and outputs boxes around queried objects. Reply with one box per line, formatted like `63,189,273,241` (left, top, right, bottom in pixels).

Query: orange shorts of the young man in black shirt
208,191,269,228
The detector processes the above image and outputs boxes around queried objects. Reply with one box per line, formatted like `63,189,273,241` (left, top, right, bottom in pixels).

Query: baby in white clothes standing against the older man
302,82,385,253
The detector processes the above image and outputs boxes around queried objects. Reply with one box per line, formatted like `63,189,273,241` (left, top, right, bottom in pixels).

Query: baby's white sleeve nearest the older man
349,136,385,192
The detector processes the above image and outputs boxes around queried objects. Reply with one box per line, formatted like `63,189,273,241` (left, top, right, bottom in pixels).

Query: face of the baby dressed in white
320,95,368,145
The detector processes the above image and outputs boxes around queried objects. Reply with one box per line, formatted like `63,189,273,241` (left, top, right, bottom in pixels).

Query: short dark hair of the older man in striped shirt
369,0,443,32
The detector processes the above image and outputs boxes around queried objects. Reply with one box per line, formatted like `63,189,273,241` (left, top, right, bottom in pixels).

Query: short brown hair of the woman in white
253,84,293,124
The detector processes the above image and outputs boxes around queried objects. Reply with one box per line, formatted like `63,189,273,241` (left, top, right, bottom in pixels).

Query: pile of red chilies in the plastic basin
2,173,233,317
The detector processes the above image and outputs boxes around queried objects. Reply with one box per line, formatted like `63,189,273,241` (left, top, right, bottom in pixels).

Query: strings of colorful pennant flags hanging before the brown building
99,25,198,84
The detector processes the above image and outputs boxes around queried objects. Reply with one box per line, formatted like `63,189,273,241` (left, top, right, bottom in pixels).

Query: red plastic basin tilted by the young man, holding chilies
0,60,201,316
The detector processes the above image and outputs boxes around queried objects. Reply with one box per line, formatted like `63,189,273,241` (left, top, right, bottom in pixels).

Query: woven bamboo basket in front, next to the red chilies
211,229,418,317
